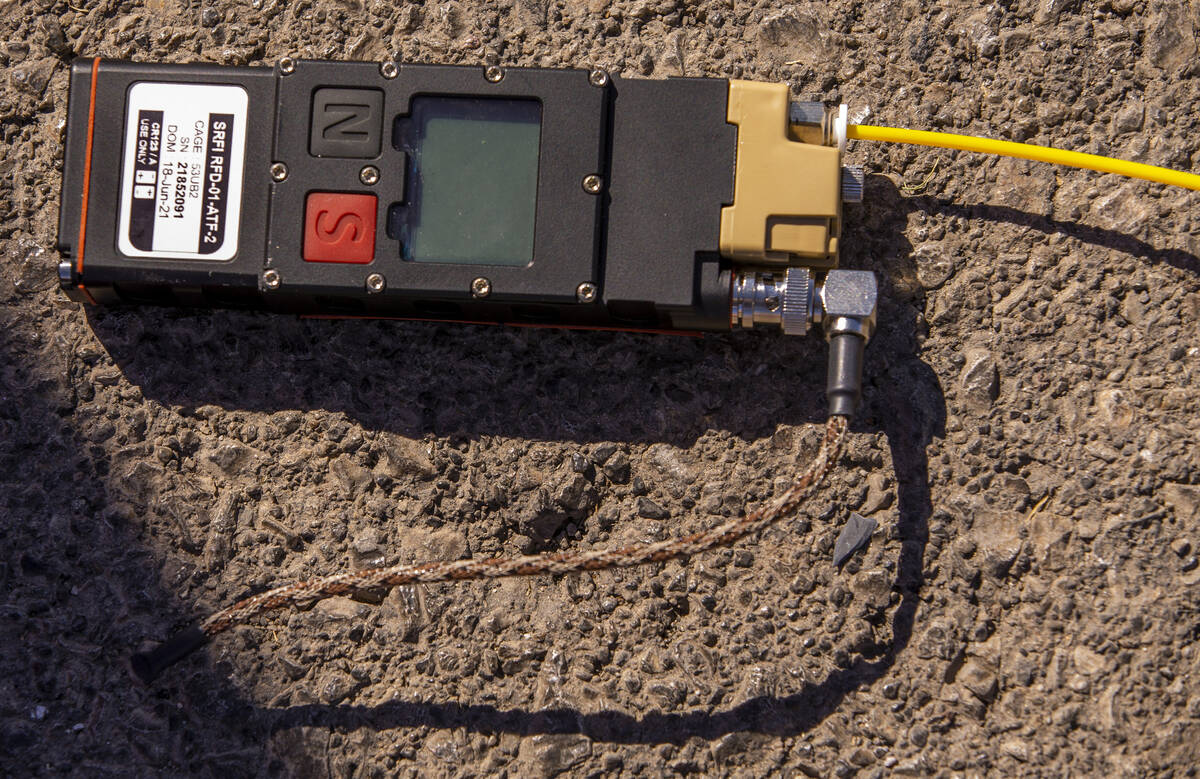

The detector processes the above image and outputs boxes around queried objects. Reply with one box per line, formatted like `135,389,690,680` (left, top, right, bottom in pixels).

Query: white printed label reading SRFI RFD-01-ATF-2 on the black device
118,82,247,260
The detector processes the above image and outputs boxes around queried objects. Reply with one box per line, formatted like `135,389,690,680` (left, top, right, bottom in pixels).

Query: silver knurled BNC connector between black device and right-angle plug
730,268,812,335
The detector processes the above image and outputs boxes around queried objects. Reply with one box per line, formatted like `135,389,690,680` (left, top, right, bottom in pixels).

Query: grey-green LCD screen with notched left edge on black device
388,96,541,265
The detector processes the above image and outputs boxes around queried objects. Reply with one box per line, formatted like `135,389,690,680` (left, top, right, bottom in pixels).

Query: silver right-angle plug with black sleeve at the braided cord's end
814,270,878,417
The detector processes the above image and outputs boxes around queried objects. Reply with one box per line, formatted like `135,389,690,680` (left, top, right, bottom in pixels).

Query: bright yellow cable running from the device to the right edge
846,125,1200,190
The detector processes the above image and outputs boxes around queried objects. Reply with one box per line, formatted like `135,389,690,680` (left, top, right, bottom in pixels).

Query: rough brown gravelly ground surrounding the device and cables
0,0,1200,777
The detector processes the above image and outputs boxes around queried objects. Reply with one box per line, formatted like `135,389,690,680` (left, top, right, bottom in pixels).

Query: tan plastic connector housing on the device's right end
720,80,841,268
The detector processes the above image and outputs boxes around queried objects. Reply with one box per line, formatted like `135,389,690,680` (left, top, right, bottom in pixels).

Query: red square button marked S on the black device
304,192,376,263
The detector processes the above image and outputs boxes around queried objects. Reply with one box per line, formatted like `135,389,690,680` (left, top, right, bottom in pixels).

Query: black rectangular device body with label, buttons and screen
59,59,737,330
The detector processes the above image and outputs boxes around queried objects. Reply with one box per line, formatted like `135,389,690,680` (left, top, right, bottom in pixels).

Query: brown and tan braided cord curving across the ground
200,417,848,637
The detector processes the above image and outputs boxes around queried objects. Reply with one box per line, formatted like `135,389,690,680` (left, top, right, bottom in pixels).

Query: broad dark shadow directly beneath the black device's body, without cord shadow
90,308,840,445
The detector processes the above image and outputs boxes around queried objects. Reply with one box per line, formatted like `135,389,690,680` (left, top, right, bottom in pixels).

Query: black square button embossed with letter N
308,88,383,158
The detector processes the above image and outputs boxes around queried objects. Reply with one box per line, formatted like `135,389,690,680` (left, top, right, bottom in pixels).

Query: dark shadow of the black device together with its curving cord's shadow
63,171,946,755
